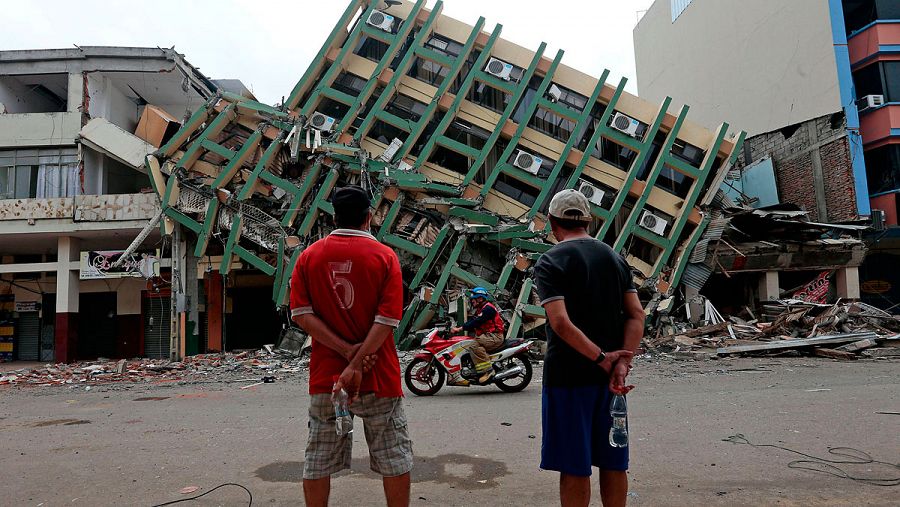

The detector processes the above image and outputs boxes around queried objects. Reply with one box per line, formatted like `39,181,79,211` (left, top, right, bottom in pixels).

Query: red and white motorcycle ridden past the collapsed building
403,328,532,396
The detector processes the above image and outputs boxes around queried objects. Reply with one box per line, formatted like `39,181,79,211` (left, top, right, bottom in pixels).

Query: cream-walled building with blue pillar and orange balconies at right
634,0,900,308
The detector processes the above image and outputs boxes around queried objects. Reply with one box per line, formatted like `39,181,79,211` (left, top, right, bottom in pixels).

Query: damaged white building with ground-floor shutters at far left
0,47,223,362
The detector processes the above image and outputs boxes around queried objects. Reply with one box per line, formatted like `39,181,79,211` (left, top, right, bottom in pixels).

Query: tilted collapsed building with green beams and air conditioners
146,0,744,362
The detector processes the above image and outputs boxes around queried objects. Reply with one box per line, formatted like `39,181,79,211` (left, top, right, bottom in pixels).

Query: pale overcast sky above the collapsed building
0,0,663,104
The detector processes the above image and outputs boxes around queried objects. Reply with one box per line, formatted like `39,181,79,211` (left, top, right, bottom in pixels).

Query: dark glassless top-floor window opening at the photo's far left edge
0,74,69,114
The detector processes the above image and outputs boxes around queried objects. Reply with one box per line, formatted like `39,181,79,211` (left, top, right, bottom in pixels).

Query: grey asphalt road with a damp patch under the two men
0,358,900,506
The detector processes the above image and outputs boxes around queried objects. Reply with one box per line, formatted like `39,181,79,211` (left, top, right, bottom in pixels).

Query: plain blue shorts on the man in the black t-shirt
541,385,628,477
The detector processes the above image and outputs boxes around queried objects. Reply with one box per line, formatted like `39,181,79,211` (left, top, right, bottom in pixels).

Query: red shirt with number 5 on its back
291,229,403,398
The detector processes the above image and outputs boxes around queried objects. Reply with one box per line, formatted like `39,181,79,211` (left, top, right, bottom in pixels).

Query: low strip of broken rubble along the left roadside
0,347,309,386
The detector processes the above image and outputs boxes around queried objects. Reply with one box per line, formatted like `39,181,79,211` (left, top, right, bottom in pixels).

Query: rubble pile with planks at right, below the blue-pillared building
644,299,900,359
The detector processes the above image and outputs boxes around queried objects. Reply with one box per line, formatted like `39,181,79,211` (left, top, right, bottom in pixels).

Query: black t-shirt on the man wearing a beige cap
534,238,635,387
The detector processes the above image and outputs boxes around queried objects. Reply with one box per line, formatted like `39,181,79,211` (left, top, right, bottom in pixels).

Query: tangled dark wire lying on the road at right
722,433,900,486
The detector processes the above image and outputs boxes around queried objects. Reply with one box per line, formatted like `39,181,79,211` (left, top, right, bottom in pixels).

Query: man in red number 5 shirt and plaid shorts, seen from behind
291,186,413,507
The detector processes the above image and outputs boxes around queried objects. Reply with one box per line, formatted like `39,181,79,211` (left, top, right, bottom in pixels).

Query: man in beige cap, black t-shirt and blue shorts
535,190,644,507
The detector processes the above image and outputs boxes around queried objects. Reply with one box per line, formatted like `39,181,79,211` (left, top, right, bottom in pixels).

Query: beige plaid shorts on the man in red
303,393,413,479
